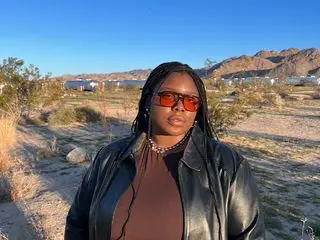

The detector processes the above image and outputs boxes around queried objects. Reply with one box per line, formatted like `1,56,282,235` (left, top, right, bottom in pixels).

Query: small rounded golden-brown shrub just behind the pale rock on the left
48,107,77,126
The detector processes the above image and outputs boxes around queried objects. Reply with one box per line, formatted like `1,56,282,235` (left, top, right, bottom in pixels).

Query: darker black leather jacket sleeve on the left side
64,150,101,240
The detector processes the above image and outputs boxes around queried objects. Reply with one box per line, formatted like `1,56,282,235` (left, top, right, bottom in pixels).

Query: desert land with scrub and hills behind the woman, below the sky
0,48,320,240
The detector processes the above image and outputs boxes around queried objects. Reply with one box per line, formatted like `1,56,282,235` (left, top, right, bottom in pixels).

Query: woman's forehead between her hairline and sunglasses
159,72,199,96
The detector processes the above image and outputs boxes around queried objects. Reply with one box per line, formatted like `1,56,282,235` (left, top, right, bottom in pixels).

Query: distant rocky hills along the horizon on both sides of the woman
56,48,320,80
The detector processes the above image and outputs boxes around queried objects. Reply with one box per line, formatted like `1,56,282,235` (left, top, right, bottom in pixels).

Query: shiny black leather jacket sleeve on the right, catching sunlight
228,154,265,240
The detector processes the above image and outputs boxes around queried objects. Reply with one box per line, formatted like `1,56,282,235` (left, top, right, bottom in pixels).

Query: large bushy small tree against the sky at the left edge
0,57,63,115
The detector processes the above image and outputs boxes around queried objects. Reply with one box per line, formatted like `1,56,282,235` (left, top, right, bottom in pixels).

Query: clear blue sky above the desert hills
0,0,320,76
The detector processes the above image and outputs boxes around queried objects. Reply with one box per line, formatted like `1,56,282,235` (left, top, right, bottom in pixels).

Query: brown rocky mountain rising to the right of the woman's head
209,48,320,78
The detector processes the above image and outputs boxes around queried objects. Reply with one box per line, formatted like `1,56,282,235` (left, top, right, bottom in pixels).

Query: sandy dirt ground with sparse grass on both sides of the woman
0,100,320,239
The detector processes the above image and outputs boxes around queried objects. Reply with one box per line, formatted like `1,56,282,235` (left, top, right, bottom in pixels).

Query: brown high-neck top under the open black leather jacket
111,139,185,240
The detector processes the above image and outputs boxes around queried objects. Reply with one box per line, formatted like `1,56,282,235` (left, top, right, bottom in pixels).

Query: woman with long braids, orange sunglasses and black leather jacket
65,62,264,240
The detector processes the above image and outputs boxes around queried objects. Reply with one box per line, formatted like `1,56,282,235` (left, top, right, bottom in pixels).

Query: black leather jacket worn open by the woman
65,126,265,240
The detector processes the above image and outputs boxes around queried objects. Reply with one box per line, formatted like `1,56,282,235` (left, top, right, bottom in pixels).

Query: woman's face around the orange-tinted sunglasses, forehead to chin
151,72,199,136
